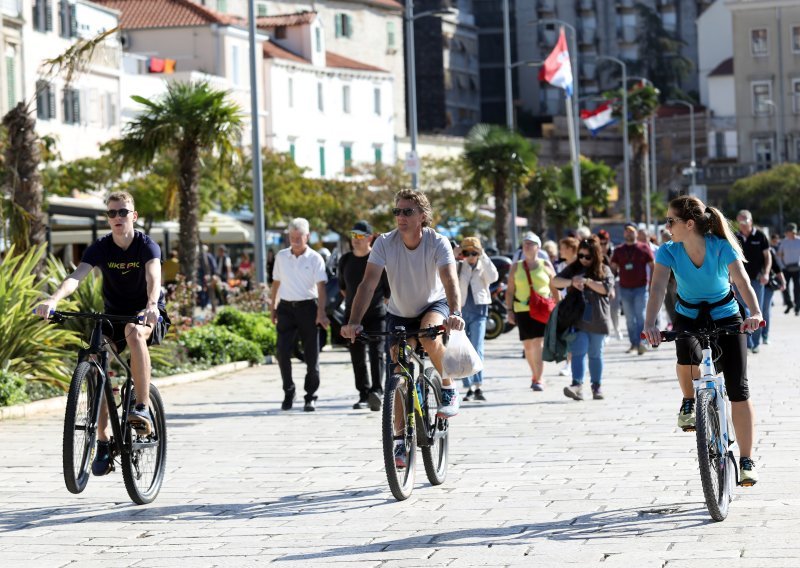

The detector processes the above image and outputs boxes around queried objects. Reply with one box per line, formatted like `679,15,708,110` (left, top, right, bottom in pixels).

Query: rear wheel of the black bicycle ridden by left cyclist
122,384,167,505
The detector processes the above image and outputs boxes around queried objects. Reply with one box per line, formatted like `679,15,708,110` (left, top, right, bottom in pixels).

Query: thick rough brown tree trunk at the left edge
3,103,47,258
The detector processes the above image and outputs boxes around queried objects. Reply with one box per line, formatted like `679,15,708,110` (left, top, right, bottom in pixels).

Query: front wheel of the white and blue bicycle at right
695,390,731,521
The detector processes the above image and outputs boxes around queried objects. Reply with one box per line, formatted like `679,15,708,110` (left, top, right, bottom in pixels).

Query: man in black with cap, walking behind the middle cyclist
337,221,391,412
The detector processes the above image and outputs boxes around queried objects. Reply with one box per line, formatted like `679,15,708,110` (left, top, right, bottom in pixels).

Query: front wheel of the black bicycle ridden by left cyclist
61,361,99,493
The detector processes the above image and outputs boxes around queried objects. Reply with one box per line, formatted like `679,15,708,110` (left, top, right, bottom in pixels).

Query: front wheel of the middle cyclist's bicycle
381,374,417,501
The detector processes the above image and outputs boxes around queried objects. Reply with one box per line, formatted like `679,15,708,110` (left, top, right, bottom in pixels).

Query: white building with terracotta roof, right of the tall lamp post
258,11,397,178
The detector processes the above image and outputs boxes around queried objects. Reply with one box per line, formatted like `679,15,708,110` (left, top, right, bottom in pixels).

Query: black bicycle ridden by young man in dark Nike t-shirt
50,311,167,505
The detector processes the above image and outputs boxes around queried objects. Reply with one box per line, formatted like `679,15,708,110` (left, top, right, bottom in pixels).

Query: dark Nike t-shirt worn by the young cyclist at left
81,231,165,315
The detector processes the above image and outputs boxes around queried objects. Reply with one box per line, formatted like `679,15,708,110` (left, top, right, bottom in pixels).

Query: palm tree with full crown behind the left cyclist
114,81,242,279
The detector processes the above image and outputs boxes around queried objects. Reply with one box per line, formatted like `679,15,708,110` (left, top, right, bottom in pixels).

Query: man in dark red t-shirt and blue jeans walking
611,223,655,355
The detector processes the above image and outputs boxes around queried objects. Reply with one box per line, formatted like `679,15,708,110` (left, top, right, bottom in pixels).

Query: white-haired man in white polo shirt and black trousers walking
270,217,330,412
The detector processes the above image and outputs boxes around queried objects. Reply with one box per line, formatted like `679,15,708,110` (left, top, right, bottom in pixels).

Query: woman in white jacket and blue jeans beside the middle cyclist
456,237,499,401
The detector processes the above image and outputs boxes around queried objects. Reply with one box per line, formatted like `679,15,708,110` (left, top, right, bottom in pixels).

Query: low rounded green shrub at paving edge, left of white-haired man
178,325,264,365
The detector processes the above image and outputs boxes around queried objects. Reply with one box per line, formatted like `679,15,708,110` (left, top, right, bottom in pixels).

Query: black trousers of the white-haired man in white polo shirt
277,300,319,401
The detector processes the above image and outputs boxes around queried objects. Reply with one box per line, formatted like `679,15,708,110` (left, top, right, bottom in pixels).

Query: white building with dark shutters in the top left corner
22,0,122,161
